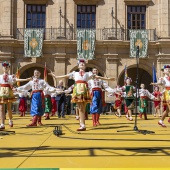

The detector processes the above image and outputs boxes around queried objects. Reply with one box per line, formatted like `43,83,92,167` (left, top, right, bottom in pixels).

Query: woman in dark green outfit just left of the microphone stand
122,77,135,121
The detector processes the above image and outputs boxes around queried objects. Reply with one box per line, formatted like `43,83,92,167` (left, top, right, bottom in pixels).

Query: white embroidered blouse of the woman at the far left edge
0,73,16,85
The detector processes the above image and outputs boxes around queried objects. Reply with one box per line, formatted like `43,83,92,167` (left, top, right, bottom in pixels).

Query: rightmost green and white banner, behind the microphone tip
129,30,148,57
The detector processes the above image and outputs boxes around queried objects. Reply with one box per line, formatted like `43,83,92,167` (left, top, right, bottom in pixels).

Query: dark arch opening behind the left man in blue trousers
20,63,55,86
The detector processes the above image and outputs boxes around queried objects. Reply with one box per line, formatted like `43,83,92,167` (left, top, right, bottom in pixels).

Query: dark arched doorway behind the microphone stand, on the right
118,67,153,92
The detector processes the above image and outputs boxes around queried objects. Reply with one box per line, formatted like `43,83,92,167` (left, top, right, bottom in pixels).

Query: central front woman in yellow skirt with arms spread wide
50,59,115,131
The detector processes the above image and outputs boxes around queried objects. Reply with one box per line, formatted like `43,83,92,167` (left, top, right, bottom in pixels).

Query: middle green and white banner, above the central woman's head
77,29,96,60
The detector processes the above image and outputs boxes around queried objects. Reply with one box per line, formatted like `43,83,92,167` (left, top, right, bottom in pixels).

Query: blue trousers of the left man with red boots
30,92,44,116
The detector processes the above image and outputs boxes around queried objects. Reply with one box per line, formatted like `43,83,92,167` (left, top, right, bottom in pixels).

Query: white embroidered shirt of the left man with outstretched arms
17,78,55,92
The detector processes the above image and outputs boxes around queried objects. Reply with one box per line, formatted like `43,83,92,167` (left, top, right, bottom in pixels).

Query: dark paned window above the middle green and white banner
77,5,96,28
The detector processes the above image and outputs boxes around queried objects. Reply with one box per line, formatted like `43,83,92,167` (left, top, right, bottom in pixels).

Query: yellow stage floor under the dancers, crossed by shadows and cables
0,115,170,169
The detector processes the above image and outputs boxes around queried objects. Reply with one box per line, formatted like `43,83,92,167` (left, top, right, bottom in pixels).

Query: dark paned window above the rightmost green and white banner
127,6,146,29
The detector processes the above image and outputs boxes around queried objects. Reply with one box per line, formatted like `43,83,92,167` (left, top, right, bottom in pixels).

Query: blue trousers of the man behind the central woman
90,90,102,114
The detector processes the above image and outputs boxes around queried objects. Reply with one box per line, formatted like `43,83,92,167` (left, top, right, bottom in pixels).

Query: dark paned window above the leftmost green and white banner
26,5,46,28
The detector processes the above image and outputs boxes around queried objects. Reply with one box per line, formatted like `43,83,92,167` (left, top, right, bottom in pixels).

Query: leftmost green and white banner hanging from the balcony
24,28,44,57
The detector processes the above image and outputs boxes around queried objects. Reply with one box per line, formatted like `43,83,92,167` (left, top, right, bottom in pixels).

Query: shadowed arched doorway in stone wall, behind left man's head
20,66,54,86
